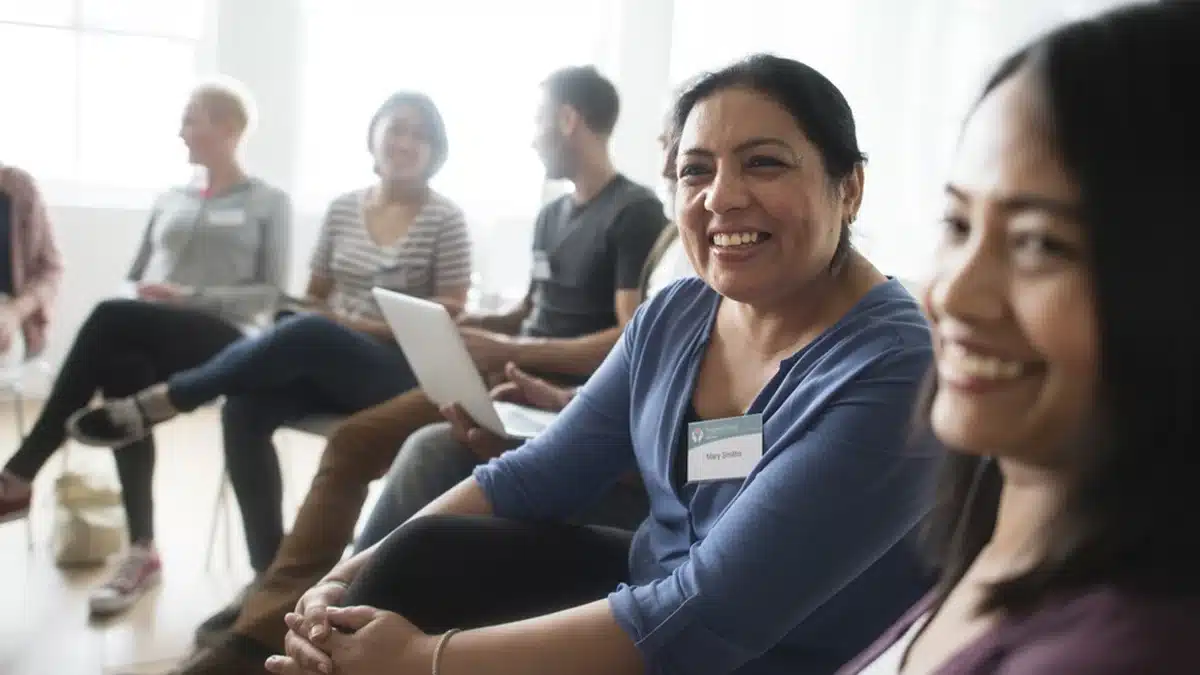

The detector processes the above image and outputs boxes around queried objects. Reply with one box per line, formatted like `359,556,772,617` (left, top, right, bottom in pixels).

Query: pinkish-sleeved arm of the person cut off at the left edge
5,167,62,354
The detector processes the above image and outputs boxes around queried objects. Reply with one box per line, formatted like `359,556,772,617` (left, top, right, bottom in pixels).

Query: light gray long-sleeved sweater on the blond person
128,178,292,325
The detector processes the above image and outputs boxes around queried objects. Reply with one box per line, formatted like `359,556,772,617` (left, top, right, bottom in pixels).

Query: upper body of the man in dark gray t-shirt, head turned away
460,66,667,383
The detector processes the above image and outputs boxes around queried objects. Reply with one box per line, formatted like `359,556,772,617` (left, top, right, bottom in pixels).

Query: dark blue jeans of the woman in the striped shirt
167,315,416,572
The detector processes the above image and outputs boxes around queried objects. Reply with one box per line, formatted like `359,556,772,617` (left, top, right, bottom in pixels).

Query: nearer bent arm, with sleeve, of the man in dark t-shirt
492,198,667,375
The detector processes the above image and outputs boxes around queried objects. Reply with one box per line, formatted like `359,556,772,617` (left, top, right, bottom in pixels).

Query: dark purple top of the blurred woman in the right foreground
838,583,1200,675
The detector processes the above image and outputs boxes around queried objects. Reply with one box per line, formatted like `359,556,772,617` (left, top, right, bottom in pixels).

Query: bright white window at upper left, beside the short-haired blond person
0,0,206,189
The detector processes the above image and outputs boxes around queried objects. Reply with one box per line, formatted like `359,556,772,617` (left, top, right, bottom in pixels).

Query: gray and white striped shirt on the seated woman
312,189,470,319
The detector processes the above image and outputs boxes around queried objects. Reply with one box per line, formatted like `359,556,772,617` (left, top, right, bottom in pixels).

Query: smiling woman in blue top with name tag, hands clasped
266,56,940,675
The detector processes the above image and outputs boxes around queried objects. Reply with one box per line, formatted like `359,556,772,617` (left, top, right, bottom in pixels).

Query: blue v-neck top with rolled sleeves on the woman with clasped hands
475,279,940,675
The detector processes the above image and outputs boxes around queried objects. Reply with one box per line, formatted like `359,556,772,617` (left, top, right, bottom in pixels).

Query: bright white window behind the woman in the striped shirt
291,0,611,220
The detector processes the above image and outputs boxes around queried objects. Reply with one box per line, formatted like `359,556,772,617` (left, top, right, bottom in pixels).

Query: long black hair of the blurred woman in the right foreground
924,2,1200,613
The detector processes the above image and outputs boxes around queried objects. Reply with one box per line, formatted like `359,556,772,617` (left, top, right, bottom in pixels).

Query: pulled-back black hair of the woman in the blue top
670,54,866,268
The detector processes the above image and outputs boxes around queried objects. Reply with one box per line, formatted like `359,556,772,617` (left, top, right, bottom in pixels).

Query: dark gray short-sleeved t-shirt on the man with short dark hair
521,174,667,338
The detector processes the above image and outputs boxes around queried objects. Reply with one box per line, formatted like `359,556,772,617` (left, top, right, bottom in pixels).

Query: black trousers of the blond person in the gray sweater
6,300,241,543
